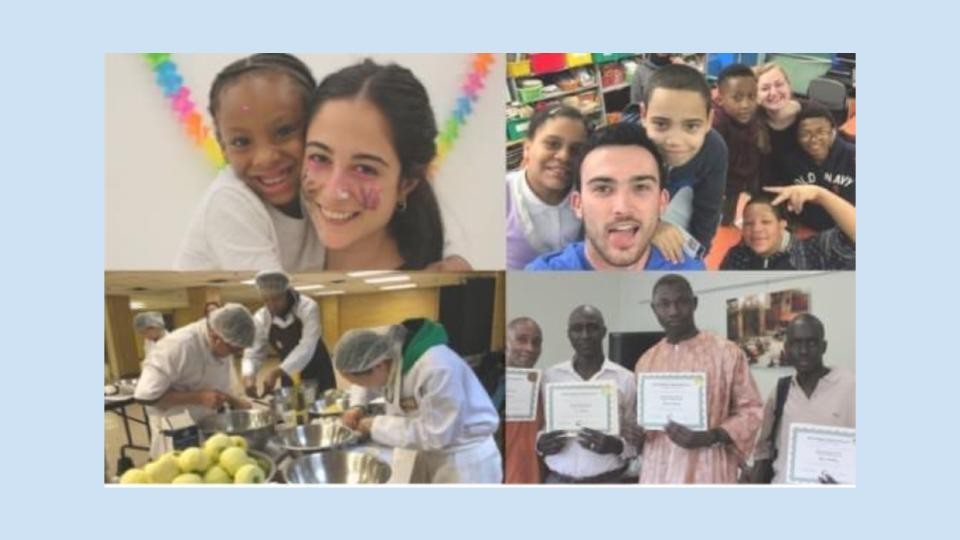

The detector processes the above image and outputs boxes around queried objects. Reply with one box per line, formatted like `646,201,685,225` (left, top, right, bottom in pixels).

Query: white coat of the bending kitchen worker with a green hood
350,345,503,483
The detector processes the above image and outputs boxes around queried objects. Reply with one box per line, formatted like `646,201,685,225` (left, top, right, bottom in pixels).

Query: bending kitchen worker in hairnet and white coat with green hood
334,319,503,483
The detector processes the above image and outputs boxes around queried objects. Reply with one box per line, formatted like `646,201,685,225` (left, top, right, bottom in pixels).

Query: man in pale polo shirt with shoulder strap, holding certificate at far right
751,313,857,484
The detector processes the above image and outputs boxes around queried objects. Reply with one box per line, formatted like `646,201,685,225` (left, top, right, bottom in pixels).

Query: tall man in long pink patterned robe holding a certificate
626,274,762,484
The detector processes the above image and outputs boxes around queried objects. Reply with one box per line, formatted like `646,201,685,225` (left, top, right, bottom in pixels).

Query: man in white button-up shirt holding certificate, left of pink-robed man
537,306,637,484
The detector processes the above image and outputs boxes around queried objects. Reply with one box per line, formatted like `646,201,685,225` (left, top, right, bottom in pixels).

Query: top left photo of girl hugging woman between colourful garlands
104,53,506,272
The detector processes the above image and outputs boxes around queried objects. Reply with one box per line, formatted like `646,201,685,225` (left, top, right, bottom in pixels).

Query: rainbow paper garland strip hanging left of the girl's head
143,53,227,170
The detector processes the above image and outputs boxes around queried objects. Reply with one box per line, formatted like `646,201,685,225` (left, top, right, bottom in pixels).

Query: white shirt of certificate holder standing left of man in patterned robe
540,359,637,478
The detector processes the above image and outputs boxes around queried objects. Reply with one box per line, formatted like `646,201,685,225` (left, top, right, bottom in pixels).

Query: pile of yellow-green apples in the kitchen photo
120,433,266,484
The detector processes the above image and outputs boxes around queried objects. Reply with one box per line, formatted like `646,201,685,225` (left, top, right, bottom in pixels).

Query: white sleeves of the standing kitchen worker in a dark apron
241,293,320,377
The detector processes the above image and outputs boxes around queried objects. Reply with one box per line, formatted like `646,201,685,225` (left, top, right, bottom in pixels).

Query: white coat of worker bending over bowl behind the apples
133,319,233,457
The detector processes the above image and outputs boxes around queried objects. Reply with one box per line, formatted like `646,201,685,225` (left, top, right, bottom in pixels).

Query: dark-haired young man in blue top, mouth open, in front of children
526,123,704,270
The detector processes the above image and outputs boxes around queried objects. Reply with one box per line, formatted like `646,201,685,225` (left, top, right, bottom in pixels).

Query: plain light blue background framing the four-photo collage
0,0,960,540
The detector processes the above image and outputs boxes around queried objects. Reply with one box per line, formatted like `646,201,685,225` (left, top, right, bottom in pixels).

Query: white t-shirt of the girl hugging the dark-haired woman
174,166,324,272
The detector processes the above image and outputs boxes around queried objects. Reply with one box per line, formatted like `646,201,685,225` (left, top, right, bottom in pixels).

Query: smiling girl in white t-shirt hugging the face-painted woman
175,54,323,272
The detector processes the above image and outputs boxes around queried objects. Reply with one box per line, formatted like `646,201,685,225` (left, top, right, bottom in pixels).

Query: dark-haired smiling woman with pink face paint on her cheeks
303,60,446,270
